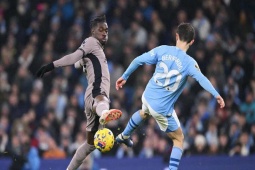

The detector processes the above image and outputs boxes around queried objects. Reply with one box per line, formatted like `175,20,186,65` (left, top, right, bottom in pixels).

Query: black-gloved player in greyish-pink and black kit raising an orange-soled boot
36,15,122,170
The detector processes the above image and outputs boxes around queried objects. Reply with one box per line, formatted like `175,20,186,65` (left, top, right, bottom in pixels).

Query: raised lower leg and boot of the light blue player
115,111,146,147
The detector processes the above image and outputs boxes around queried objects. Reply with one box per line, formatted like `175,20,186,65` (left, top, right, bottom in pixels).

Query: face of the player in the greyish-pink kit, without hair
92,22,108,45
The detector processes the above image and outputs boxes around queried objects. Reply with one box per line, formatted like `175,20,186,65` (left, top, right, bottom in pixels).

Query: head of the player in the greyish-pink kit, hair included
90,15,108,45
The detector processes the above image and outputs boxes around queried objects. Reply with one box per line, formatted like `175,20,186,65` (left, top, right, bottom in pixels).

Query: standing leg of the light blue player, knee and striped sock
167,127,184,170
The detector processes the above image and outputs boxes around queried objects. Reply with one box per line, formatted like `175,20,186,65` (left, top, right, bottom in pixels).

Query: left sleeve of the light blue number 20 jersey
121,47,159,80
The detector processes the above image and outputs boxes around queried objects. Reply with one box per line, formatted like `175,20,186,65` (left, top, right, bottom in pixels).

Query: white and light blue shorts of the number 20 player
142,96,180,133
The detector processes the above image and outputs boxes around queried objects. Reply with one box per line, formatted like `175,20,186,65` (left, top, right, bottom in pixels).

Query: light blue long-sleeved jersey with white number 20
122,45,219,116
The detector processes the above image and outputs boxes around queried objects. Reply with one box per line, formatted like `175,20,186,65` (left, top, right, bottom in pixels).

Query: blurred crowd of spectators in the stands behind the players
0,0,255,170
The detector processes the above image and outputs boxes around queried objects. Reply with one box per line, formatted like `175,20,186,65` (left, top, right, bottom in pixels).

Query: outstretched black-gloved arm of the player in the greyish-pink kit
36,39,94,77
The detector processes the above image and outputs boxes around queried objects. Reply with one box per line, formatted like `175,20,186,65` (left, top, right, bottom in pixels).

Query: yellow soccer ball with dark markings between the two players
94,128,114,152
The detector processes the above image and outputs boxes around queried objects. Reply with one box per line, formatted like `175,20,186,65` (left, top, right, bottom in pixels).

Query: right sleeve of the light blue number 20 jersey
188,60,219,97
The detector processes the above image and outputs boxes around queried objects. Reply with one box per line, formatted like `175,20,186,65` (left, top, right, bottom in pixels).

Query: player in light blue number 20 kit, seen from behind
116,23,225,170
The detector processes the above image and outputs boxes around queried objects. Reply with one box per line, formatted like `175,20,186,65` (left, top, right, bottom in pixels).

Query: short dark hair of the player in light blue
177,23,195,43
